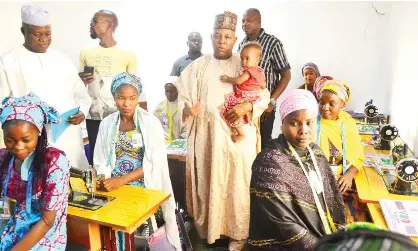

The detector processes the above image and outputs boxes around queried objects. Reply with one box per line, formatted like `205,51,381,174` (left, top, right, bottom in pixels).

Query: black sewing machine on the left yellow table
68,166,114,210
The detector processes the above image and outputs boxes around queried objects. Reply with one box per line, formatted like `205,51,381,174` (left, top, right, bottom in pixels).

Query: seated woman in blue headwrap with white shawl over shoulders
94,73,181,250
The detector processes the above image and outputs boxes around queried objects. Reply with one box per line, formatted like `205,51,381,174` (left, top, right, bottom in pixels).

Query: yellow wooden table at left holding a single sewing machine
67,178,170,251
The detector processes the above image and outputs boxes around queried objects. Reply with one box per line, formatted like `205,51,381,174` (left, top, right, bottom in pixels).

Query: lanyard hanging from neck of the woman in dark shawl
287,142,337,234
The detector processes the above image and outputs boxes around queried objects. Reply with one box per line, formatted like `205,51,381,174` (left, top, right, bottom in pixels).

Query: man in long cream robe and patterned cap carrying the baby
177,12,270,250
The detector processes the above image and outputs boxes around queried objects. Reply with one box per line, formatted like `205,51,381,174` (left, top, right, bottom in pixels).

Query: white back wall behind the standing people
0,0,418,147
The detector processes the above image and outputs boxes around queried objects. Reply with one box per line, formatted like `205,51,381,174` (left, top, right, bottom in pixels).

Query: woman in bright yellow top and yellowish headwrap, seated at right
314,80,364,193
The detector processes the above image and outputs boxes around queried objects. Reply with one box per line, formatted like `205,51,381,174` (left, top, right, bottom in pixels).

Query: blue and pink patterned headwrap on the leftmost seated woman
0,92,60,132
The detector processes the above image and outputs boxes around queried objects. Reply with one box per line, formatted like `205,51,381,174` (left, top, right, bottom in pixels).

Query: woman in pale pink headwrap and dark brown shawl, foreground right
249,89,345,250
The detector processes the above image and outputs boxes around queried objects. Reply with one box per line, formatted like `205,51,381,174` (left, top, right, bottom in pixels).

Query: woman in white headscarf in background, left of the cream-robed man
154,76,186,143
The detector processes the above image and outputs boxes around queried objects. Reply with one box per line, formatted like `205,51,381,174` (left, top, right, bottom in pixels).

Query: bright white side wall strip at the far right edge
388,2,418,155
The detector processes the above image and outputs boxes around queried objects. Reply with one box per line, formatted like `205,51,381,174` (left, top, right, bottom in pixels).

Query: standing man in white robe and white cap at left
0,5,91,169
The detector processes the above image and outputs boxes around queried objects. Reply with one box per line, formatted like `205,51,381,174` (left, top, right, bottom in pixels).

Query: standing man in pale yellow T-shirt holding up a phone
79,10,147,162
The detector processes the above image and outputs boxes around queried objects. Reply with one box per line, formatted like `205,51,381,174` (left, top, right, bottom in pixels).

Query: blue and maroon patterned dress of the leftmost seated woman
0,147,70,251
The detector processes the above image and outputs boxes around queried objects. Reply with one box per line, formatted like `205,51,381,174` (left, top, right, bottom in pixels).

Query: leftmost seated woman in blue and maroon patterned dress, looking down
0,93,69,250
